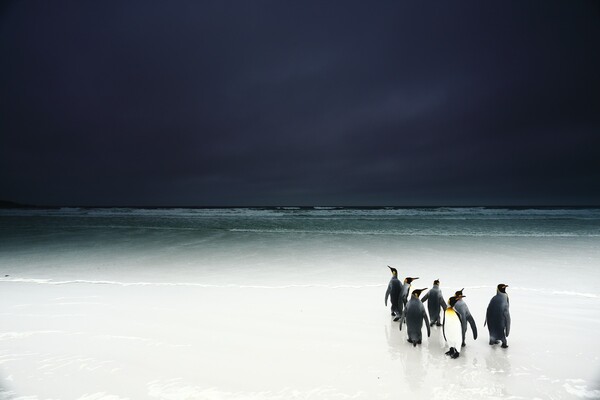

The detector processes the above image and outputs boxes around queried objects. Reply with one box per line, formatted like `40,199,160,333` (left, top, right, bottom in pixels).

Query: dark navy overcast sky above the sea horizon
0,0,600,206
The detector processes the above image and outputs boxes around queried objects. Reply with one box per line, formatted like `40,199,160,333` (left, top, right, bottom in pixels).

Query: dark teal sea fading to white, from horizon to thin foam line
0,207,600,294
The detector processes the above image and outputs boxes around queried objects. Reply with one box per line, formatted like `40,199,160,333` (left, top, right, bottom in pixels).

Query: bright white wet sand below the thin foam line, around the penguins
0,276,600,399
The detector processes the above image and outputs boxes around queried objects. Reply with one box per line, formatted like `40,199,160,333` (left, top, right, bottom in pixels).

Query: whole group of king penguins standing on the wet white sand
385,265,510,358
